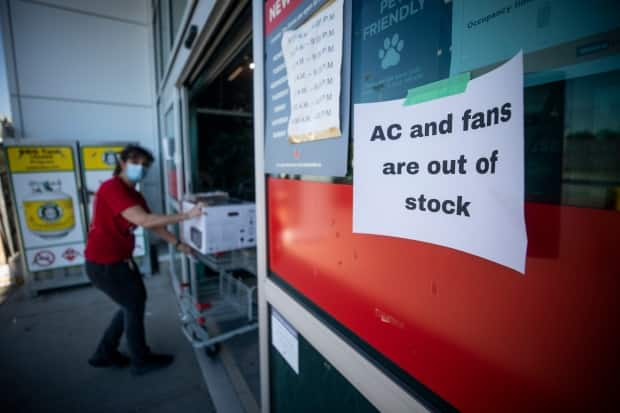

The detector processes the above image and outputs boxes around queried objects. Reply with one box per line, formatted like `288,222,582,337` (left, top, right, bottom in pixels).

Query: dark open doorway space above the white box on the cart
189,39,254,202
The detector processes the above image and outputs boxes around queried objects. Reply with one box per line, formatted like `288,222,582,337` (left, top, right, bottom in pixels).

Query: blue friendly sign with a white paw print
352,0,452,103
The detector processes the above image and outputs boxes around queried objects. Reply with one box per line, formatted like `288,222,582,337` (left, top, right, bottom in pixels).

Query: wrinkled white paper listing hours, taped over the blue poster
280,0,344,143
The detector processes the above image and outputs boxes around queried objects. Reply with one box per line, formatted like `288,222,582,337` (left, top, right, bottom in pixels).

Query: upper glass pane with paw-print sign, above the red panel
352,0,620,210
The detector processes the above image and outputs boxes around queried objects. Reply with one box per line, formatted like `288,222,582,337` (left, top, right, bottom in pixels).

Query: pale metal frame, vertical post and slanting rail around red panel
252,0,428,412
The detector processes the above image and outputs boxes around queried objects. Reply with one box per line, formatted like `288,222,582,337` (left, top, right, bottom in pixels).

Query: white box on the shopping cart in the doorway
181,201,256,254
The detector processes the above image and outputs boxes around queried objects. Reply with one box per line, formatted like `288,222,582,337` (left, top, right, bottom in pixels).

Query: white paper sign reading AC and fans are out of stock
353,53,527,273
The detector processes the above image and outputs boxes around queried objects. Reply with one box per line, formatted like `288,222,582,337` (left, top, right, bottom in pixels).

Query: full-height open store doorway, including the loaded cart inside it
183,6,260,411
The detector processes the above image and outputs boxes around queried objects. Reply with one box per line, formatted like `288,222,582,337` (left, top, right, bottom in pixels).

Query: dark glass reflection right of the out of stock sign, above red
524,71,620,209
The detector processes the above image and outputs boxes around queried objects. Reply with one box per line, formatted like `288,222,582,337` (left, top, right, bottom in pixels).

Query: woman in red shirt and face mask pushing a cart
85,145,202,375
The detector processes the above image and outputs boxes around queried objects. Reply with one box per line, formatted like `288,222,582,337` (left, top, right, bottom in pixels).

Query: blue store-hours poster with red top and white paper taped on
265,0,350,176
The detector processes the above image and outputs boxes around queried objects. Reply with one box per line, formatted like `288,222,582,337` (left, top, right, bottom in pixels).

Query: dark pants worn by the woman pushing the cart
86,261,149,364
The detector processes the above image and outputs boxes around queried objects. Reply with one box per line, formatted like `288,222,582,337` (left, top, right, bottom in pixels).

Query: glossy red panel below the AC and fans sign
268,179,620,412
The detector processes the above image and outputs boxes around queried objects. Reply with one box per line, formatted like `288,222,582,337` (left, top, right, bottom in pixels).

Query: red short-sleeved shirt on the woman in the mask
84,176,151,264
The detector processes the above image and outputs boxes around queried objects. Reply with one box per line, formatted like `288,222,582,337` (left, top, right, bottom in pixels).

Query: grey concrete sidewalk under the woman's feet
0,275,215,413
